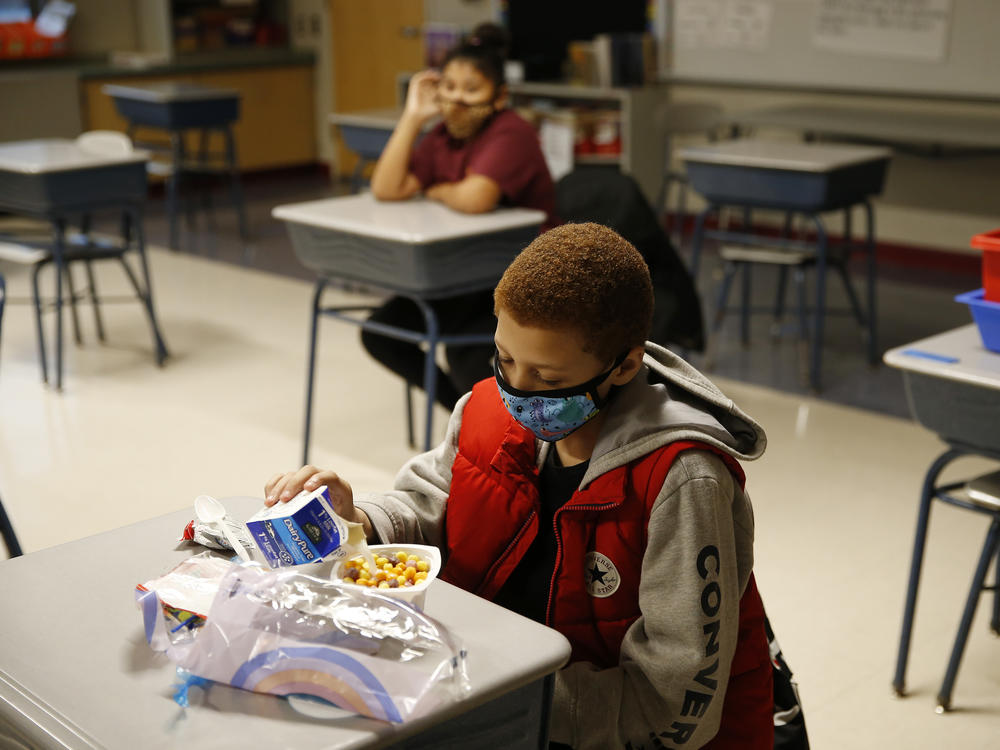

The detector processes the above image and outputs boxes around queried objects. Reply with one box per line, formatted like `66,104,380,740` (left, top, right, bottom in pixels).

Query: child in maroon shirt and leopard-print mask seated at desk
361,24,558,409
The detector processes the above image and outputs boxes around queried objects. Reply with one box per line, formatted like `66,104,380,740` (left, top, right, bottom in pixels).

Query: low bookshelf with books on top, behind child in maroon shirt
509,83,668,205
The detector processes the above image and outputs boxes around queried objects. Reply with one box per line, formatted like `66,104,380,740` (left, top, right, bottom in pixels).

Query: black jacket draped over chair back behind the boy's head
556,168,705,352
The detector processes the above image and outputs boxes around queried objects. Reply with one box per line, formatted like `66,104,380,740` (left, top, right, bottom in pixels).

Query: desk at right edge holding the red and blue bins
884,325,1000,712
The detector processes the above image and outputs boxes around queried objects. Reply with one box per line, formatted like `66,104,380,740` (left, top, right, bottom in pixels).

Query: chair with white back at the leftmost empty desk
0,130,168,383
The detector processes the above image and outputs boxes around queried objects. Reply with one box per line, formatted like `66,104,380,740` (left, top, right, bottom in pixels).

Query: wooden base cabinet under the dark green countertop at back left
80,65,317,170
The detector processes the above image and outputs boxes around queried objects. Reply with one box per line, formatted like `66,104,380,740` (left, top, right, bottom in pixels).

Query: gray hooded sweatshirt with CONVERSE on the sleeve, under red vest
356,343,766,750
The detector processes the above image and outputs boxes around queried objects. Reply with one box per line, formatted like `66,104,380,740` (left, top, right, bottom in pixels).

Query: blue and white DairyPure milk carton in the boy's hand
246,486,366,568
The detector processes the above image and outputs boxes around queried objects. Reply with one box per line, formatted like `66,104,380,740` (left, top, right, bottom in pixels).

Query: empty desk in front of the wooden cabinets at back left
101,82,247,248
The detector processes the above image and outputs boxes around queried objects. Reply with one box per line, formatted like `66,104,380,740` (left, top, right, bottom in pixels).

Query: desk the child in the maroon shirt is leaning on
272,193,545,463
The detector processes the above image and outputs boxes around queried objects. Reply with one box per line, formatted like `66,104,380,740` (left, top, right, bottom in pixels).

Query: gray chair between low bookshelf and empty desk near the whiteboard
654,101,723,253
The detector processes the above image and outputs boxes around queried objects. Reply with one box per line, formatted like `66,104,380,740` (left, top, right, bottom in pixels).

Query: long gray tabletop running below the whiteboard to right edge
730,104,1000,148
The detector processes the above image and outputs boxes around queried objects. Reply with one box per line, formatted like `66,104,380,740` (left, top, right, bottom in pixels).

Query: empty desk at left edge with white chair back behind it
0,138,167,389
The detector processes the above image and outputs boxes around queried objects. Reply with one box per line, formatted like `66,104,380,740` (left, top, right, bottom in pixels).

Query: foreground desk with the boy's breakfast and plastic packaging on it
0,498,570,750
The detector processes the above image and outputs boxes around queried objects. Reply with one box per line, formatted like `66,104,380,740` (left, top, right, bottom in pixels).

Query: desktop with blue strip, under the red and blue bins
882,324,1000,390
